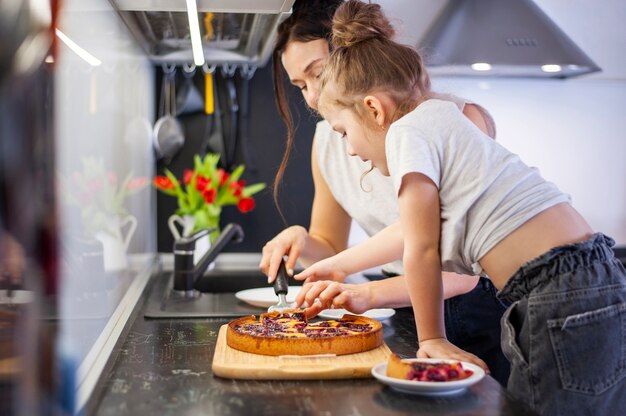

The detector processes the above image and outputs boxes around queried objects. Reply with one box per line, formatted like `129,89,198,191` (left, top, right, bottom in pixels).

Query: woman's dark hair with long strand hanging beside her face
272,0,343,221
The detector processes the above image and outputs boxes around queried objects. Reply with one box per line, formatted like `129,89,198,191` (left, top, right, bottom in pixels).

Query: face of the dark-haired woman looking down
282,39,330,110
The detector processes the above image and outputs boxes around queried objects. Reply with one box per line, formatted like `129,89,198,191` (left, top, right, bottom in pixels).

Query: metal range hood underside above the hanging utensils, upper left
110,0,294,66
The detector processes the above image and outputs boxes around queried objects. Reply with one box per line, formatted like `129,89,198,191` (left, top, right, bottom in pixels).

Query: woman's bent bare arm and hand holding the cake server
259,144,352,283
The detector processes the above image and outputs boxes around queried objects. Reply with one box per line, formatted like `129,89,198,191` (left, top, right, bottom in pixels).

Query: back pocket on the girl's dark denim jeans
548,303,626,395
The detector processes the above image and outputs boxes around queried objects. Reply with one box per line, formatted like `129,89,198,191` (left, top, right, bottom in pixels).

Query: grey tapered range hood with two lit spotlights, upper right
418,0,600,78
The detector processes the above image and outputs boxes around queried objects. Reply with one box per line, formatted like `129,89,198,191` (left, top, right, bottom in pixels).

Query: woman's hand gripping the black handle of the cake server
259,225,309,283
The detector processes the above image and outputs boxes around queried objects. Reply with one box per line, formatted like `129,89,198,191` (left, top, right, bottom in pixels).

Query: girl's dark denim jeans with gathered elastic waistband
498,234,626,415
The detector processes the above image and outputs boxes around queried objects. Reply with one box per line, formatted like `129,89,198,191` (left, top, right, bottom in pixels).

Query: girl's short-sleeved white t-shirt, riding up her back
385,99,570,274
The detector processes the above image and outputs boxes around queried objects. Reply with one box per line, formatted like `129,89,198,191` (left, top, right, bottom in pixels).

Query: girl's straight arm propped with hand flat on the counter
398,173,488,371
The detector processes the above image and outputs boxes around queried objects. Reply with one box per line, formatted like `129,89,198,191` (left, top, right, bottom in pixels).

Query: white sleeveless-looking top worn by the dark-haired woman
314,94,468,274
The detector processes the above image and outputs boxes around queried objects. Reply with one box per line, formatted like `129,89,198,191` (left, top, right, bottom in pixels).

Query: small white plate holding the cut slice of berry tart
372,358,485,396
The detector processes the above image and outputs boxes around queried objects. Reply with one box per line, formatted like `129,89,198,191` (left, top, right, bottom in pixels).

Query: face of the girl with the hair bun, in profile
320,105,389,176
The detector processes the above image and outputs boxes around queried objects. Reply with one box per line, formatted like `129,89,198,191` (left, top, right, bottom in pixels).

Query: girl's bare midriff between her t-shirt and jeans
480,203,593,289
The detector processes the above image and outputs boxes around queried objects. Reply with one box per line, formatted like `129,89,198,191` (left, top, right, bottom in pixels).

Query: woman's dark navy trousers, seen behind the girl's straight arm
444,277,510,386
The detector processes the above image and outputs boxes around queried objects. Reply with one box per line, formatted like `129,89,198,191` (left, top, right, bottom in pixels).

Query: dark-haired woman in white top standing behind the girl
260,0,508,383
